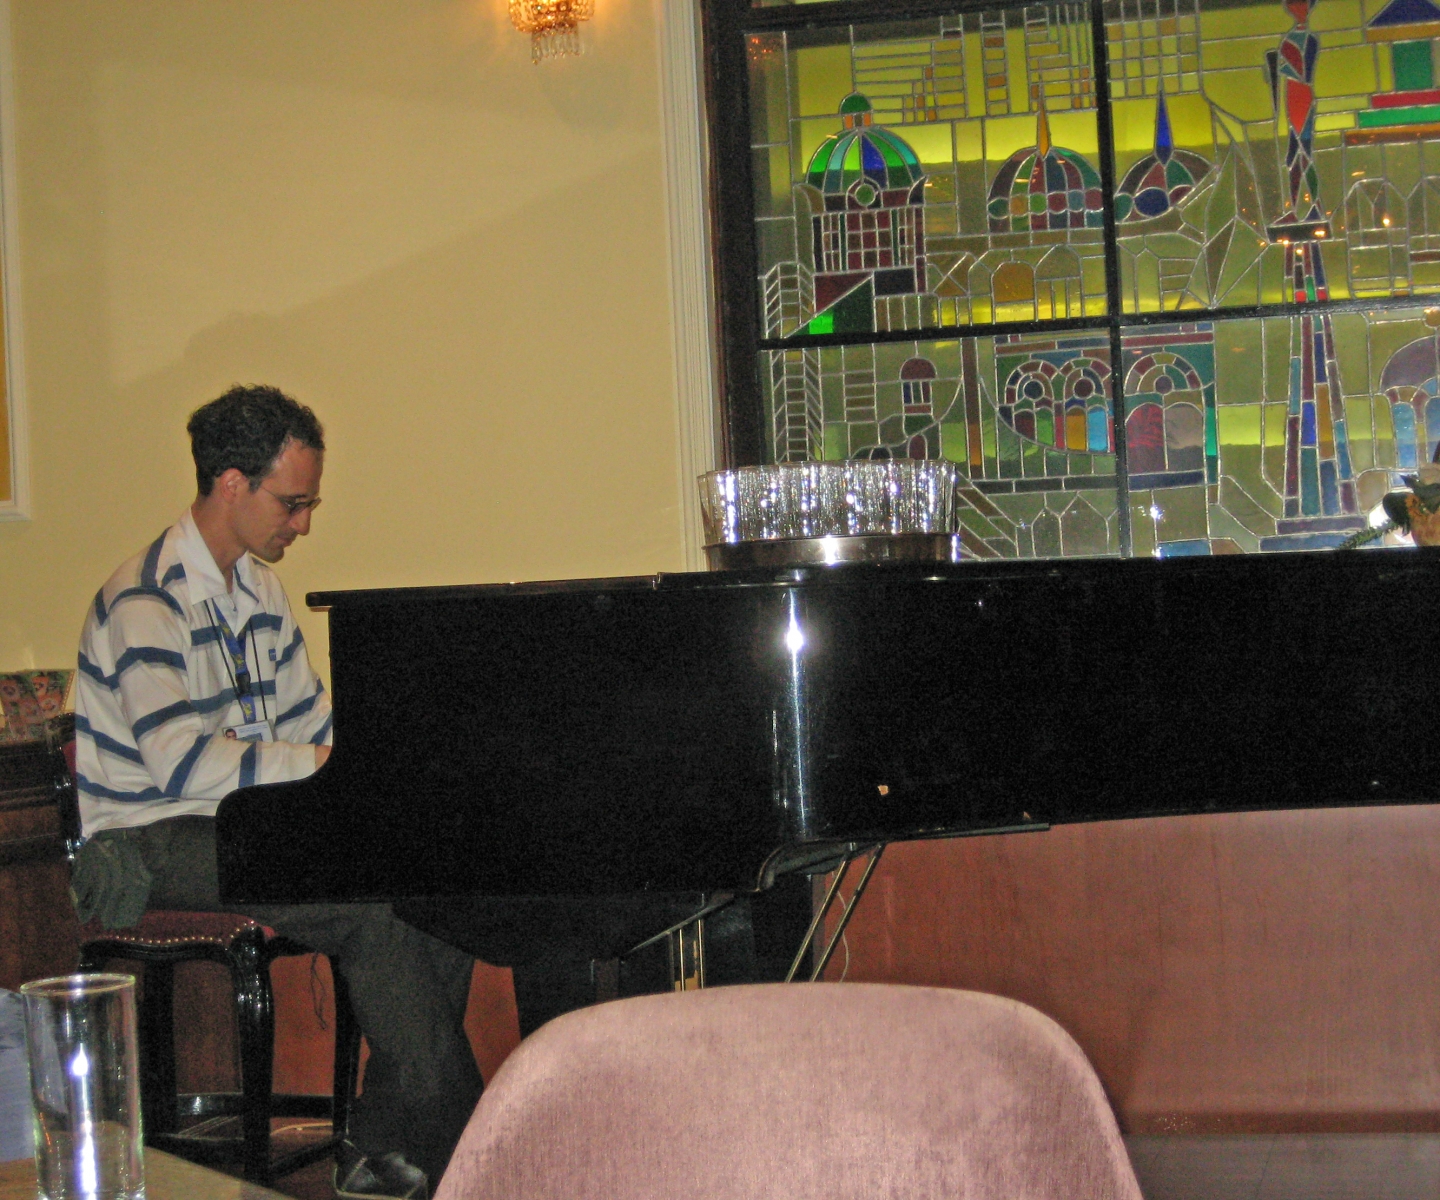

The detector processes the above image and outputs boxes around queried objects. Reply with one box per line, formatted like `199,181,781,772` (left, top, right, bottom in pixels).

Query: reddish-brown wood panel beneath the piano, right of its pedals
829,807,1440,1132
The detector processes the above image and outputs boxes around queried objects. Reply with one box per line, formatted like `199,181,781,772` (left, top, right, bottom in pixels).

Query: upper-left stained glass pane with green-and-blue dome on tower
750,7,1106,337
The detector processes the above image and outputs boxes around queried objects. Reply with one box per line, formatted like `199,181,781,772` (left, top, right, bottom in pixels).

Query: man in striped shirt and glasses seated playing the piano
73,388,481,1197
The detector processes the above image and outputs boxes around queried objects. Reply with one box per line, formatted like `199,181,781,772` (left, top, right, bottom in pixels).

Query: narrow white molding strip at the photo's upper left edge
0,0,30,520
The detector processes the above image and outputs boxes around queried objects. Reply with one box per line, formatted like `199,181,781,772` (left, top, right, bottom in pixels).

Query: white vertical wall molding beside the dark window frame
655,0,720,570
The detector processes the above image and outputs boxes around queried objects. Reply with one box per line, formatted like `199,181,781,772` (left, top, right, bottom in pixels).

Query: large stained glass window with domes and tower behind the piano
707,0,1440,558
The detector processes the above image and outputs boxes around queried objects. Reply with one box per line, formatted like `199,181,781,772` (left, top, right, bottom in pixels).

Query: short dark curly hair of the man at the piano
186,383,325,496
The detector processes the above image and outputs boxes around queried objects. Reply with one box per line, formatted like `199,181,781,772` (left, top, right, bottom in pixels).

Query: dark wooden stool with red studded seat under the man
79,910,360,1184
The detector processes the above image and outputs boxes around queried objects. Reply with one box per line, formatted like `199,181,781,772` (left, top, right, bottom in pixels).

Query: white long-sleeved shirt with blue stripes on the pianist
75,511,330,837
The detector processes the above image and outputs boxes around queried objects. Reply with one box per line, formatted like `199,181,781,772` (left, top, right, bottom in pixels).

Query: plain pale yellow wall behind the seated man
0,0,683,674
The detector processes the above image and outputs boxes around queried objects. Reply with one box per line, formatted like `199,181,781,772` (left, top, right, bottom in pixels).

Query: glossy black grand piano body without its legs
219,550,1440,902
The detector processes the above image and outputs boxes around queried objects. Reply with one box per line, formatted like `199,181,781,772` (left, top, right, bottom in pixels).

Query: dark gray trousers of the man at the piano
116,817,481,1184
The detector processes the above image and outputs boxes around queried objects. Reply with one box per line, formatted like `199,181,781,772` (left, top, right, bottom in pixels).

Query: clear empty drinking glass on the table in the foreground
20,974,145,1200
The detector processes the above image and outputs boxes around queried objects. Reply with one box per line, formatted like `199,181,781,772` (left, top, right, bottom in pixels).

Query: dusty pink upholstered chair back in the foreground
435,984,1140,1200
